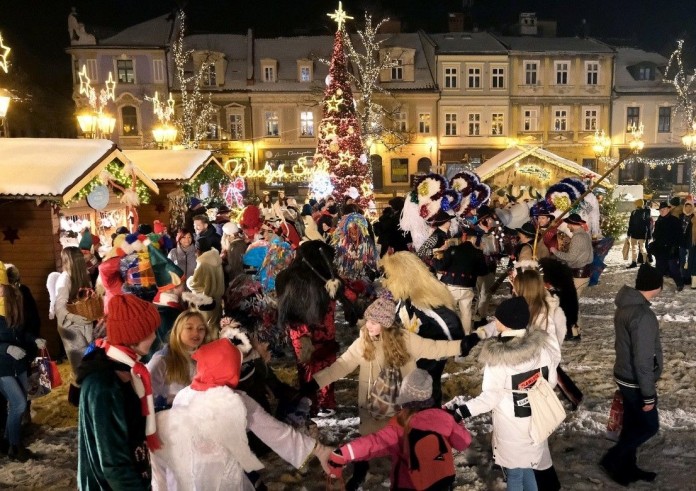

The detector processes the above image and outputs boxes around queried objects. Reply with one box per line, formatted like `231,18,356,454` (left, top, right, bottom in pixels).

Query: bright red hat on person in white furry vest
191,338,242,391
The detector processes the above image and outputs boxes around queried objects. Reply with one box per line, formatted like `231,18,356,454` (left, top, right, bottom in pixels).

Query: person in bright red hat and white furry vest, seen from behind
152,339,330,491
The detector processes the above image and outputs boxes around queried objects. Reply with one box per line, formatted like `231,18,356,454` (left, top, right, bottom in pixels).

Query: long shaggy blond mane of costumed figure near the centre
380,251,455,310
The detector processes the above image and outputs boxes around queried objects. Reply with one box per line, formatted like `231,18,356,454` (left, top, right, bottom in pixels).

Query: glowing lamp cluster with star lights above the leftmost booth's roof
77,65,116,138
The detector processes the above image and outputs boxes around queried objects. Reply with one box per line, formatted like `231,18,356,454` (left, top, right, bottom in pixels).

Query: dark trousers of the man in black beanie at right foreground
605,385,660,473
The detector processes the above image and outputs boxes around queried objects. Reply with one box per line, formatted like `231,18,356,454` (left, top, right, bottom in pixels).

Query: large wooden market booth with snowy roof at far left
0,138,158,353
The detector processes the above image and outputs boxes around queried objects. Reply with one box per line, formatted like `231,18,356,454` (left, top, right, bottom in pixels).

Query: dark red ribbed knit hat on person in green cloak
106,295,161,346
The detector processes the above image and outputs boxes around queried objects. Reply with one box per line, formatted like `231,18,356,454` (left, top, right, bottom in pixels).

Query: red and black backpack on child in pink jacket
395,425,456,491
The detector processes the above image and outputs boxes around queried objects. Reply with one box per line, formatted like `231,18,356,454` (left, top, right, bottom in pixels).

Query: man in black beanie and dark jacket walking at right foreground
600,266,669,486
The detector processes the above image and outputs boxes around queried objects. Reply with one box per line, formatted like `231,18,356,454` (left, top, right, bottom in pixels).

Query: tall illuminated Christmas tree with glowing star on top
315,2,373,208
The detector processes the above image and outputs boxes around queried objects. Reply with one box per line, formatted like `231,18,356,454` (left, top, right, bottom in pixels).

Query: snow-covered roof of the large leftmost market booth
0,138,159,202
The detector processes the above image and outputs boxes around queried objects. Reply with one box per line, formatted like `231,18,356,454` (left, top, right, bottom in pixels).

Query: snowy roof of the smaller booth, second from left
123,149,224,181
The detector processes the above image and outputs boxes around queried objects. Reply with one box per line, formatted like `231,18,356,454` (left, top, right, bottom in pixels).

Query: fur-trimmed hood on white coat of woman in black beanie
479,331,548,366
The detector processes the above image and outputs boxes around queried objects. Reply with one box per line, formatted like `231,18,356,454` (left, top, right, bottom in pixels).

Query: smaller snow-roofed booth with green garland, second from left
123,149,223,232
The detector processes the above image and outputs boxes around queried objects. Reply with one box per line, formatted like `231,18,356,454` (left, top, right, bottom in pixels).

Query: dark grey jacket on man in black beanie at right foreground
614,285,663,405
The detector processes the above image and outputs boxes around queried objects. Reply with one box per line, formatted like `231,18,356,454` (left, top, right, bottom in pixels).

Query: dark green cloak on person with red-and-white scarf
77,349,151,491
